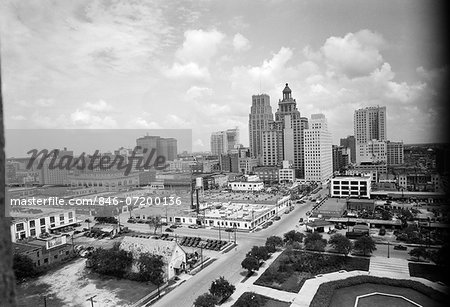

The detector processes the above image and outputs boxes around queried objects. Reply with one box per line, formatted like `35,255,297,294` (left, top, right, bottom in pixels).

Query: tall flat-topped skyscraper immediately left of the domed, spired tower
248,94,273,158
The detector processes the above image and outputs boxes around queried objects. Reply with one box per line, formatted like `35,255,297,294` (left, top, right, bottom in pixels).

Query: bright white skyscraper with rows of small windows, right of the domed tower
304,114,333,183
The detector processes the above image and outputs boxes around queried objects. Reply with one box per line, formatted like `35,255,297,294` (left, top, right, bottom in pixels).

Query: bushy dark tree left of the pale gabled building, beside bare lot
89,244,133,278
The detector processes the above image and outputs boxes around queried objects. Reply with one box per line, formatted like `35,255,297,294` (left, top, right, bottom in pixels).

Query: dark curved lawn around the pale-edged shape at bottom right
329,283,444,307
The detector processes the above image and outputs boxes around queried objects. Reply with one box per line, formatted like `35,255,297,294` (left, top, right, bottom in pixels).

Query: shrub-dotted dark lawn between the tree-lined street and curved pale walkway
255,249,370,293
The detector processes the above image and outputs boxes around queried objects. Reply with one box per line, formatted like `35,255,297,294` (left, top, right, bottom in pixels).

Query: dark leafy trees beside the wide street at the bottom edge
194,276,236,307
